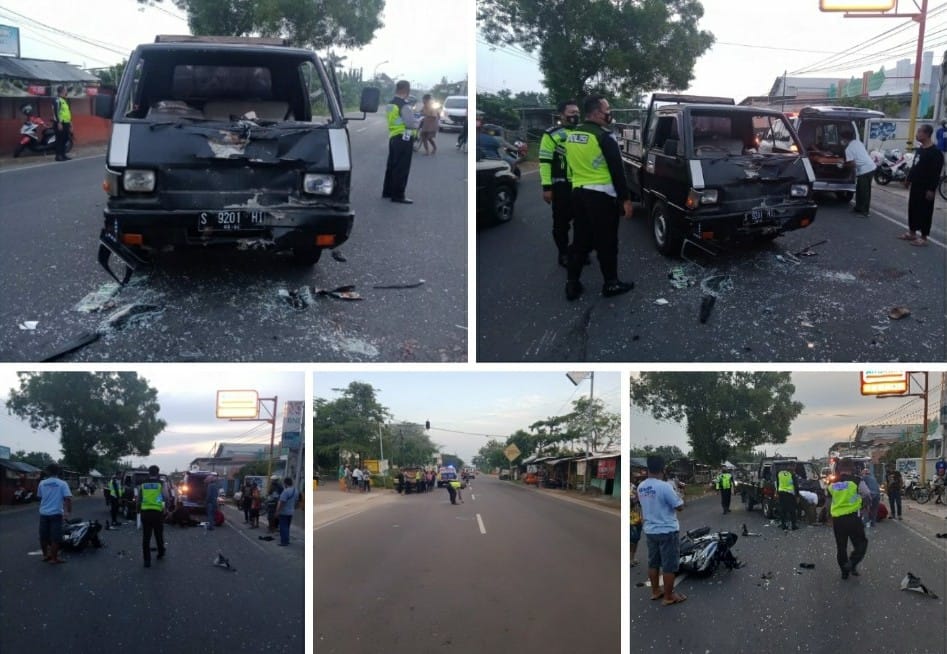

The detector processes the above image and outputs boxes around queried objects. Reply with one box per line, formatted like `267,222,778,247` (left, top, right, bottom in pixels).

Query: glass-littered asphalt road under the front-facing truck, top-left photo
0,115,467,362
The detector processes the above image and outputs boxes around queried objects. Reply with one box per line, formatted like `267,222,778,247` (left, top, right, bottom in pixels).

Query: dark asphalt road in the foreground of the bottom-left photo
0,495,305,654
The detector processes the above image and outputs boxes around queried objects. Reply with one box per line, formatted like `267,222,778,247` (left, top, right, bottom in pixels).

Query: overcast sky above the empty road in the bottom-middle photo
313,371,621,463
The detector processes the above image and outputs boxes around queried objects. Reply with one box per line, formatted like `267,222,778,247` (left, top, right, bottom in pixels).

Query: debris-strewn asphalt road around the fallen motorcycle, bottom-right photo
629,496,947,654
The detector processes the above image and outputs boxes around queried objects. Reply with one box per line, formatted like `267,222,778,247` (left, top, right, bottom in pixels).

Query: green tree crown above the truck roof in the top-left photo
137,0,385,50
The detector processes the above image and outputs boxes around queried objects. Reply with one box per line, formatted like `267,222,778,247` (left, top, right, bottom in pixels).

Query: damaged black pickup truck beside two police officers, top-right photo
618,93,816,255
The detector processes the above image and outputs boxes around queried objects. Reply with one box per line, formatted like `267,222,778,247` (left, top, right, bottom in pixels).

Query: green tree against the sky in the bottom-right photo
631,372,803,465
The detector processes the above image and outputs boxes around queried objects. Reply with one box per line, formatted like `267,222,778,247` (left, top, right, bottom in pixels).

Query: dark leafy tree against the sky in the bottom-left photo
6,372,167,474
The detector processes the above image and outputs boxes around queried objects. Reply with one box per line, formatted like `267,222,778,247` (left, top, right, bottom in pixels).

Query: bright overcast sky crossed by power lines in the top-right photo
477,0,947,102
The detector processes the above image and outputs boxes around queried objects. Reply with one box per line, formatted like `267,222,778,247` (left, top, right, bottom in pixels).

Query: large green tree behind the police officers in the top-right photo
477,0,714,98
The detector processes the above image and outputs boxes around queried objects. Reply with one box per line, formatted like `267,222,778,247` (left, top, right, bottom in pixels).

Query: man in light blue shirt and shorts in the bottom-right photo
638,456,687,606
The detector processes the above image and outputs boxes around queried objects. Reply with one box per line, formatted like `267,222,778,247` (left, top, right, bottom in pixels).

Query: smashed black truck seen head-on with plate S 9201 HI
96,36,378,284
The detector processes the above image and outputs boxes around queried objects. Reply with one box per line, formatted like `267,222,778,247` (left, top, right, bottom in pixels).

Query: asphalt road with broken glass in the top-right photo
477,172,947,362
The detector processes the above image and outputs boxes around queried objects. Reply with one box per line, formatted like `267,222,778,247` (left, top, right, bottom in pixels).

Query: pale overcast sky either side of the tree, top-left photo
0,0,466,86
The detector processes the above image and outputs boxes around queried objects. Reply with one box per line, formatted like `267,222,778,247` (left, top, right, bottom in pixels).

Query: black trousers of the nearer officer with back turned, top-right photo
569,188,618,283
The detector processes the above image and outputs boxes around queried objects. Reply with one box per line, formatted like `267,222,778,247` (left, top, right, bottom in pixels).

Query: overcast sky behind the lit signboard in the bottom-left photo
0,372,306,471
